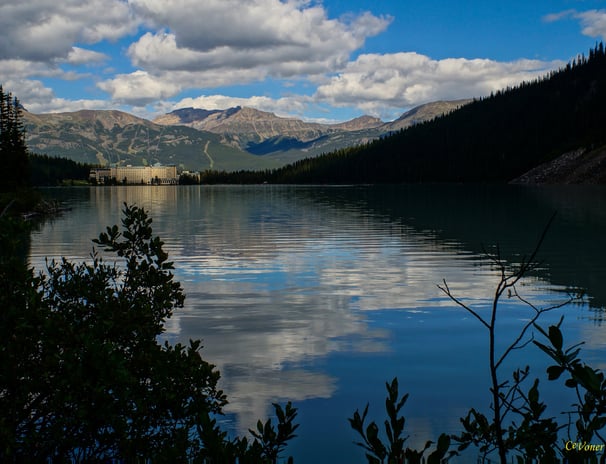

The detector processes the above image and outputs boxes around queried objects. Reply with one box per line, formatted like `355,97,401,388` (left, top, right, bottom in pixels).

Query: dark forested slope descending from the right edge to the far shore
201,43,606,183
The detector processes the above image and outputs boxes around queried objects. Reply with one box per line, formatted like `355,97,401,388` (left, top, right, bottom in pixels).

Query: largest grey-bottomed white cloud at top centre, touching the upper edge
114,0,391,95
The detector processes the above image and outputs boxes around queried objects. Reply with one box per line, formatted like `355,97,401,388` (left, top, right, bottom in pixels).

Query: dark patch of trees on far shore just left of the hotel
29,153,92,186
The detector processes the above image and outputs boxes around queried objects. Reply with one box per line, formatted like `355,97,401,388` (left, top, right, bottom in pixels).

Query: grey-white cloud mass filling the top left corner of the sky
0,0,136,113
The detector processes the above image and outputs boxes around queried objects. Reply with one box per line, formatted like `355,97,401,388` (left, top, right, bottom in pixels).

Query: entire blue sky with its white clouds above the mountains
0,0,606,122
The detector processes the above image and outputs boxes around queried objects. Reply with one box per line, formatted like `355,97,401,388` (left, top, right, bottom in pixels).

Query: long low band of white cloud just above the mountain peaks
99,52,564,120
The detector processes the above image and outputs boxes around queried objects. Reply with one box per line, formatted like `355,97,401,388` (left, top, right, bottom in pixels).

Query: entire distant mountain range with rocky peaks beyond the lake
23,100,469,171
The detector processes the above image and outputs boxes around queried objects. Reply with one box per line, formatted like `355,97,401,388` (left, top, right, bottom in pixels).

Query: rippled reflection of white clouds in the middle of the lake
156,187,568,430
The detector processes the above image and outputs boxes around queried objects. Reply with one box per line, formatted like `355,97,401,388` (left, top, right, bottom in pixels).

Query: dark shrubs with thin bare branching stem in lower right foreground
349,217,606,464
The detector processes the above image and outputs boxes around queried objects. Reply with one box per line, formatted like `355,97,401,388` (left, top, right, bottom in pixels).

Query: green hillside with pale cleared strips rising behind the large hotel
24,110,278,171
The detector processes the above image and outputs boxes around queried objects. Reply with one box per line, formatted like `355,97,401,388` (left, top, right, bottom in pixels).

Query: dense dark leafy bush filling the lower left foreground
0,205,297,463
